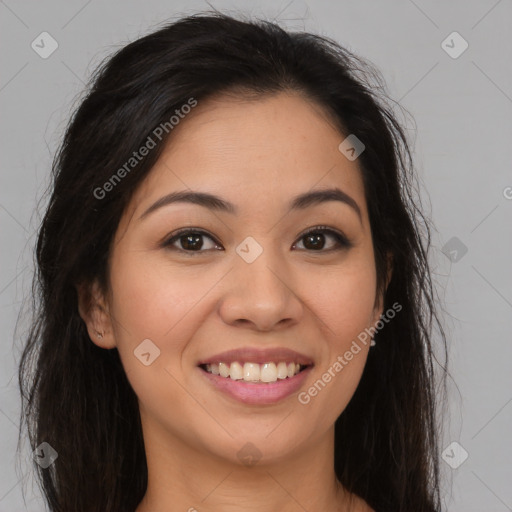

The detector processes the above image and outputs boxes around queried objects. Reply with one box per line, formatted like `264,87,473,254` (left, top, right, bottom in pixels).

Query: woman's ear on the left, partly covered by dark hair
76,280,116,349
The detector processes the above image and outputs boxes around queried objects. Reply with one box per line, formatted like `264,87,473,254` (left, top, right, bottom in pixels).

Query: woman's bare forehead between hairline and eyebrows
125,89,365,220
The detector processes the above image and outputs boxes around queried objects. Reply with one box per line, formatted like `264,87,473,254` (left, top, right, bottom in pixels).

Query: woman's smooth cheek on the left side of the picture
111,248,223,388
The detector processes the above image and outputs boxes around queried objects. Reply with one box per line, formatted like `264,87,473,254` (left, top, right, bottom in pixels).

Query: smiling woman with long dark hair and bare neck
20,12,445,512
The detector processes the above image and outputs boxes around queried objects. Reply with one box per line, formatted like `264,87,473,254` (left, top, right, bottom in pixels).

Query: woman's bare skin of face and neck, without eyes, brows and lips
80,93,383,512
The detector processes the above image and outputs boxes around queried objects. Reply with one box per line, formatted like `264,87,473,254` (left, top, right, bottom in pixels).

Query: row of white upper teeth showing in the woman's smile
205,361,301,382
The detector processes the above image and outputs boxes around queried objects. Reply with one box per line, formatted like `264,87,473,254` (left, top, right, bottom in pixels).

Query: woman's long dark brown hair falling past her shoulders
19,11,447,512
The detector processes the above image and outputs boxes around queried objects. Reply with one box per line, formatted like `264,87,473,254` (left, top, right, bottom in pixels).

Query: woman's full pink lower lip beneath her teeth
199,366,312,405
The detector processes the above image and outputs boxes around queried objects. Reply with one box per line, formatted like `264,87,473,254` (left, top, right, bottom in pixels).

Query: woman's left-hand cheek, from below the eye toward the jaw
107,250,207,422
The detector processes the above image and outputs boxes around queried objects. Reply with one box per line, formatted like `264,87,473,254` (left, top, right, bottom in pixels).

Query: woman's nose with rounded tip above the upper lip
219,251,304,331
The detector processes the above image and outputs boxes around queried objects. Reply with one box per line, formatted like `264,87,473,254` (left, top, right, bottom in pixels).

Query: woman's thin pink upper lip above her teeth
197,347,313,366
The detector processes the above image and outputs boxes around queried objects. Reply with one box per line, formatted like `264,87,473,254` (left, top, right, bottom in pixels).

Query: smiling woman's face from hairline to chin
81,93,382,468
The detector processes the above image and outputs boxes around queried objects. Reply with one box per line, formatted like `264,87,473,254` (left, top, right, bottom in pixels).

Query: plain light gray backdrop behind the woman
0,0,512,512
